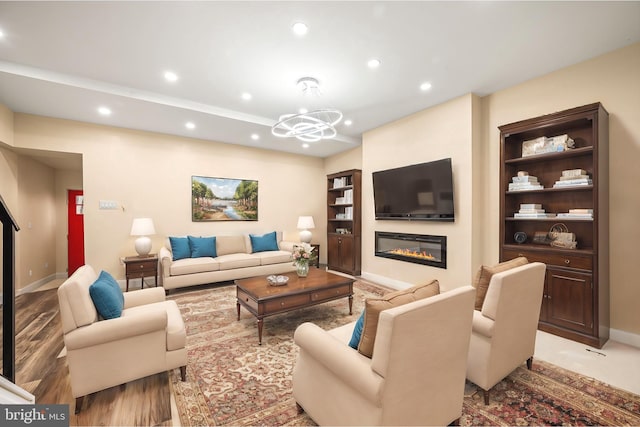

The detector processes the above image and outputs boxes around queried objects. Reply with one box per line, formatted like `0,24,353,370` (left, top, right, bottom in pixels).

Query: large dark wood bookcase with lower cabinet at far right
499,103,609,348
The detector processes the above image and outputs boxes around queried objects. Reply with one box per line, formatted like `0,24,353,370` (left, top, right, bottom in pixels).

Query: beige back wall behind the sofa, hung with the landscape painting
14,114,326,278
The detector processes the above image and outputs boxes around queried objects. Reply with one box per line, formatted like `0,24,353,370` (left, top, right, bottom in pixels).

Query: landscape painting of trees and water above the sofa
191,176,258,222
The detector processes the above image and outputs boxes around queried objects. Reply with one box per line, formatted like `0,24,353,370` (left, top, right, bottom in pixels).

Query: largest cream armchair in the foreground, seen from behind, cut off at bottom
293,286,475,425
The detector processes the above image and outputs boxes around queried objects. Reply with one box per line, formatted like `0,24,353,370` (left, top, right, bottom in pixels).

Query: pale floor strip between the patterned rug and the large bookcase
533,331,640,395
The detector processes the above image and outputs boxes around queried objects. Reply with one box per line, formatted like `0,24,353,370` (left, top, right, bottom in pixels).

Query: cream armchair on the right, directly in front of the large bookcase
467,262,545,405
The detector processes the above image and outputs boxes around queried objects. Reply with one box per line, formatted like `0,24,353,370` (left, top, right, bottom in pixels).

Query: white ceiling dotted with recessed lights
0,1,640,165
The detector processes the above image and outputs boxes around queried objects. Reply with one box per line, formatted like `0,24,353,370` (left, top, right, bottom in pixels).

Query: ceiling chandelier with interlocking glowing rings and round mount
271,77,342,142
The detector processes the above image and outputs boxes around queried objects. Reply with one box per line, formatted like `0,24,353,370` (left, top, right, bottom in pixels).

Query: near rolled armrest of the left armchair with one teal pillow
64,307,167,351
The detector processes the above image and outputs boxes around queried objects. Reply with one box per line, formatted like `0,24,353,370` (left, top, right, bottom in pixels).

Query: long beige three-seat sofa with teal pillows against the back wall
159,232,296,290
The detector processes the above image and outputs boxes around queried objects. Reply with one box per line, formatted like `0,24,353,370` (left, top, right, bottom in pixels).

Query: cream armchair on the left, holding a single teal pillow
58,265,187,413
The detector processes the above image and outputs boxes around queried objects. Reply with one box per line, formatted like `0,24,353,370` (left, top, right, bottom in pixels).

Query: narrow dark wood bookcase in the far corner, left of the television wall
327,169,362,276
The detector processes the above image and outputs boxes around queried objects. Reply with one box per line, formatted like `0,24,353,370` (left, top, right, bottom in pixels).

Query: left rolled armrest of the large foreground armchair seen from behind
293,322,384,403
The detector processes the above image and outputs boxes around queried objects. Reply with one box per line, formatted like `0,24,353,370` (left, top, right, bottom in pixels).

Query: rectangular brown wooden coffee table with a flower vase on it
235,268,354,345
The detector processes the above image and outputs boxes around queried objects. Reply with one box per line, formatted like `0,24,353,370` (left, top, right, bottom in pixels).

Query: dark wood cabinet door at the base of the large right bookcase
541,266,593,333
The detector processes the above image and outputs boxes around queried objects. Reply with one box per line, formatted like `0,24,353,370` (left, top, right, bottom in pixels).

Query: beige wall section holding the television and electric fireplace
362,95,479,289
